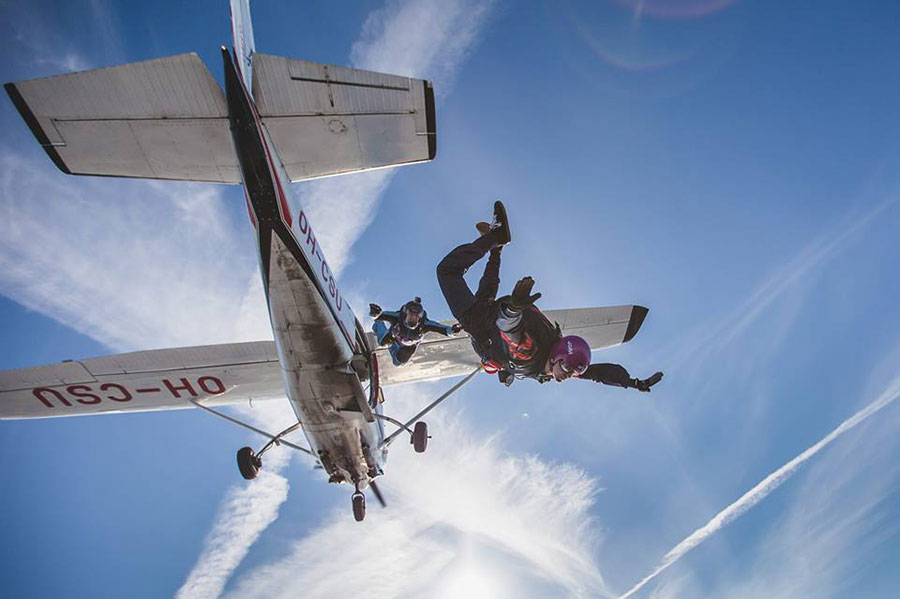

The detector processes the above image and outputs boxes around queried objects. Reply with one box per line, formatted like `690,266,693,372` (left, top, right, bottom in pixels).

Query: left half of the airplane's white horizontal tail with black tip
5,53,241,183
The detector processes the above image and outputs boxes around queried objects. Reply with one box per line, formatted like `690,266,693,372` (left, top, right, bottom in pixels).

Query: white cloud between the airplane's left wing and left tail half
0,147,271,350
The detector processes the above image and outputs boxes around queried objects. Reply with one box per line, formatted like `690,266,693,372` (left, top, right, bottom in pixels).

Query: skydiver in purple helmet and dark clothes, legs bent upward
437,201,663,392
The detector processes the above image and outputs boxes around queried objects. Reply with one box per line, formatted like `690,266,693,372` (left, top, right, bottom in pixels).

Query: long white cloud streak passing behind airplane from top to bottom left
180,0,500,597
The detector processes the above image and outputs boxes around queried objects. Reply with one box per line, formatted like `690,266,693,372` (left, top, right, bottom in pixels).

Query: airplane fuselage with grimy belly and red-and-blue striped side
223,49,385,486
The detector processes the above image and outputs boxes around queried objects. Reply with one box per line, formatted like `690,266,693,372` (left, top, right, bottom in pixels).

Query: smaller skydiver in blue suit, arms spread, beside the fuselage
369,297,462,366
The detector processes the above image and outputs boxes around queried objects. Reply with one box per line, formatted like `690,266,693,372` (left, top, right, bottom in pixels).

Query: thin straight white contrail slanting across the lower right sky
619,377,900,599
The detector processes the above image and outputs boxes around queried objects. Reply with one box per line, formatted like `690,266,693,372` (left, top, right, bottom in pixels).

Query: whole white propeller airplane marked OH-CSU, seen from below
0,0,647,521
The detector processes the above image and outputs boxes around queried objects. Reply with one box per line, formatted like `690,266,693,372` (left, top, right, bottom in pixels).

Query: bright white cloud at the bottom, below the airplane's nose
221,386,606,598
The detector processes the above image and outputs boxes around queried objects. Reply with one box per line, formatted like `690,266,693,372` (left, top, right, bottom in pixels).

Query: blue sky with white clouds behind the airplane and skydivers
0,0,900,599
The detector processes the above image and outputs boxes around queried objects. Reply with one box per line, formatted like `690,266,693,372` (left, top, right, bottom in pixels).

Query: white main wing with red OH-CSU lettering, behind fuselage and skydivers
0,306,647,420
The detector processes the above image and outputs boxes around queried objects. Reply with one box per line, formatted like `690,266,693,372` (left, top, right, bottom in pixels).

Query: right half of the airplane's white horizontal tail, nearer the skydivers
253,53,437,181
